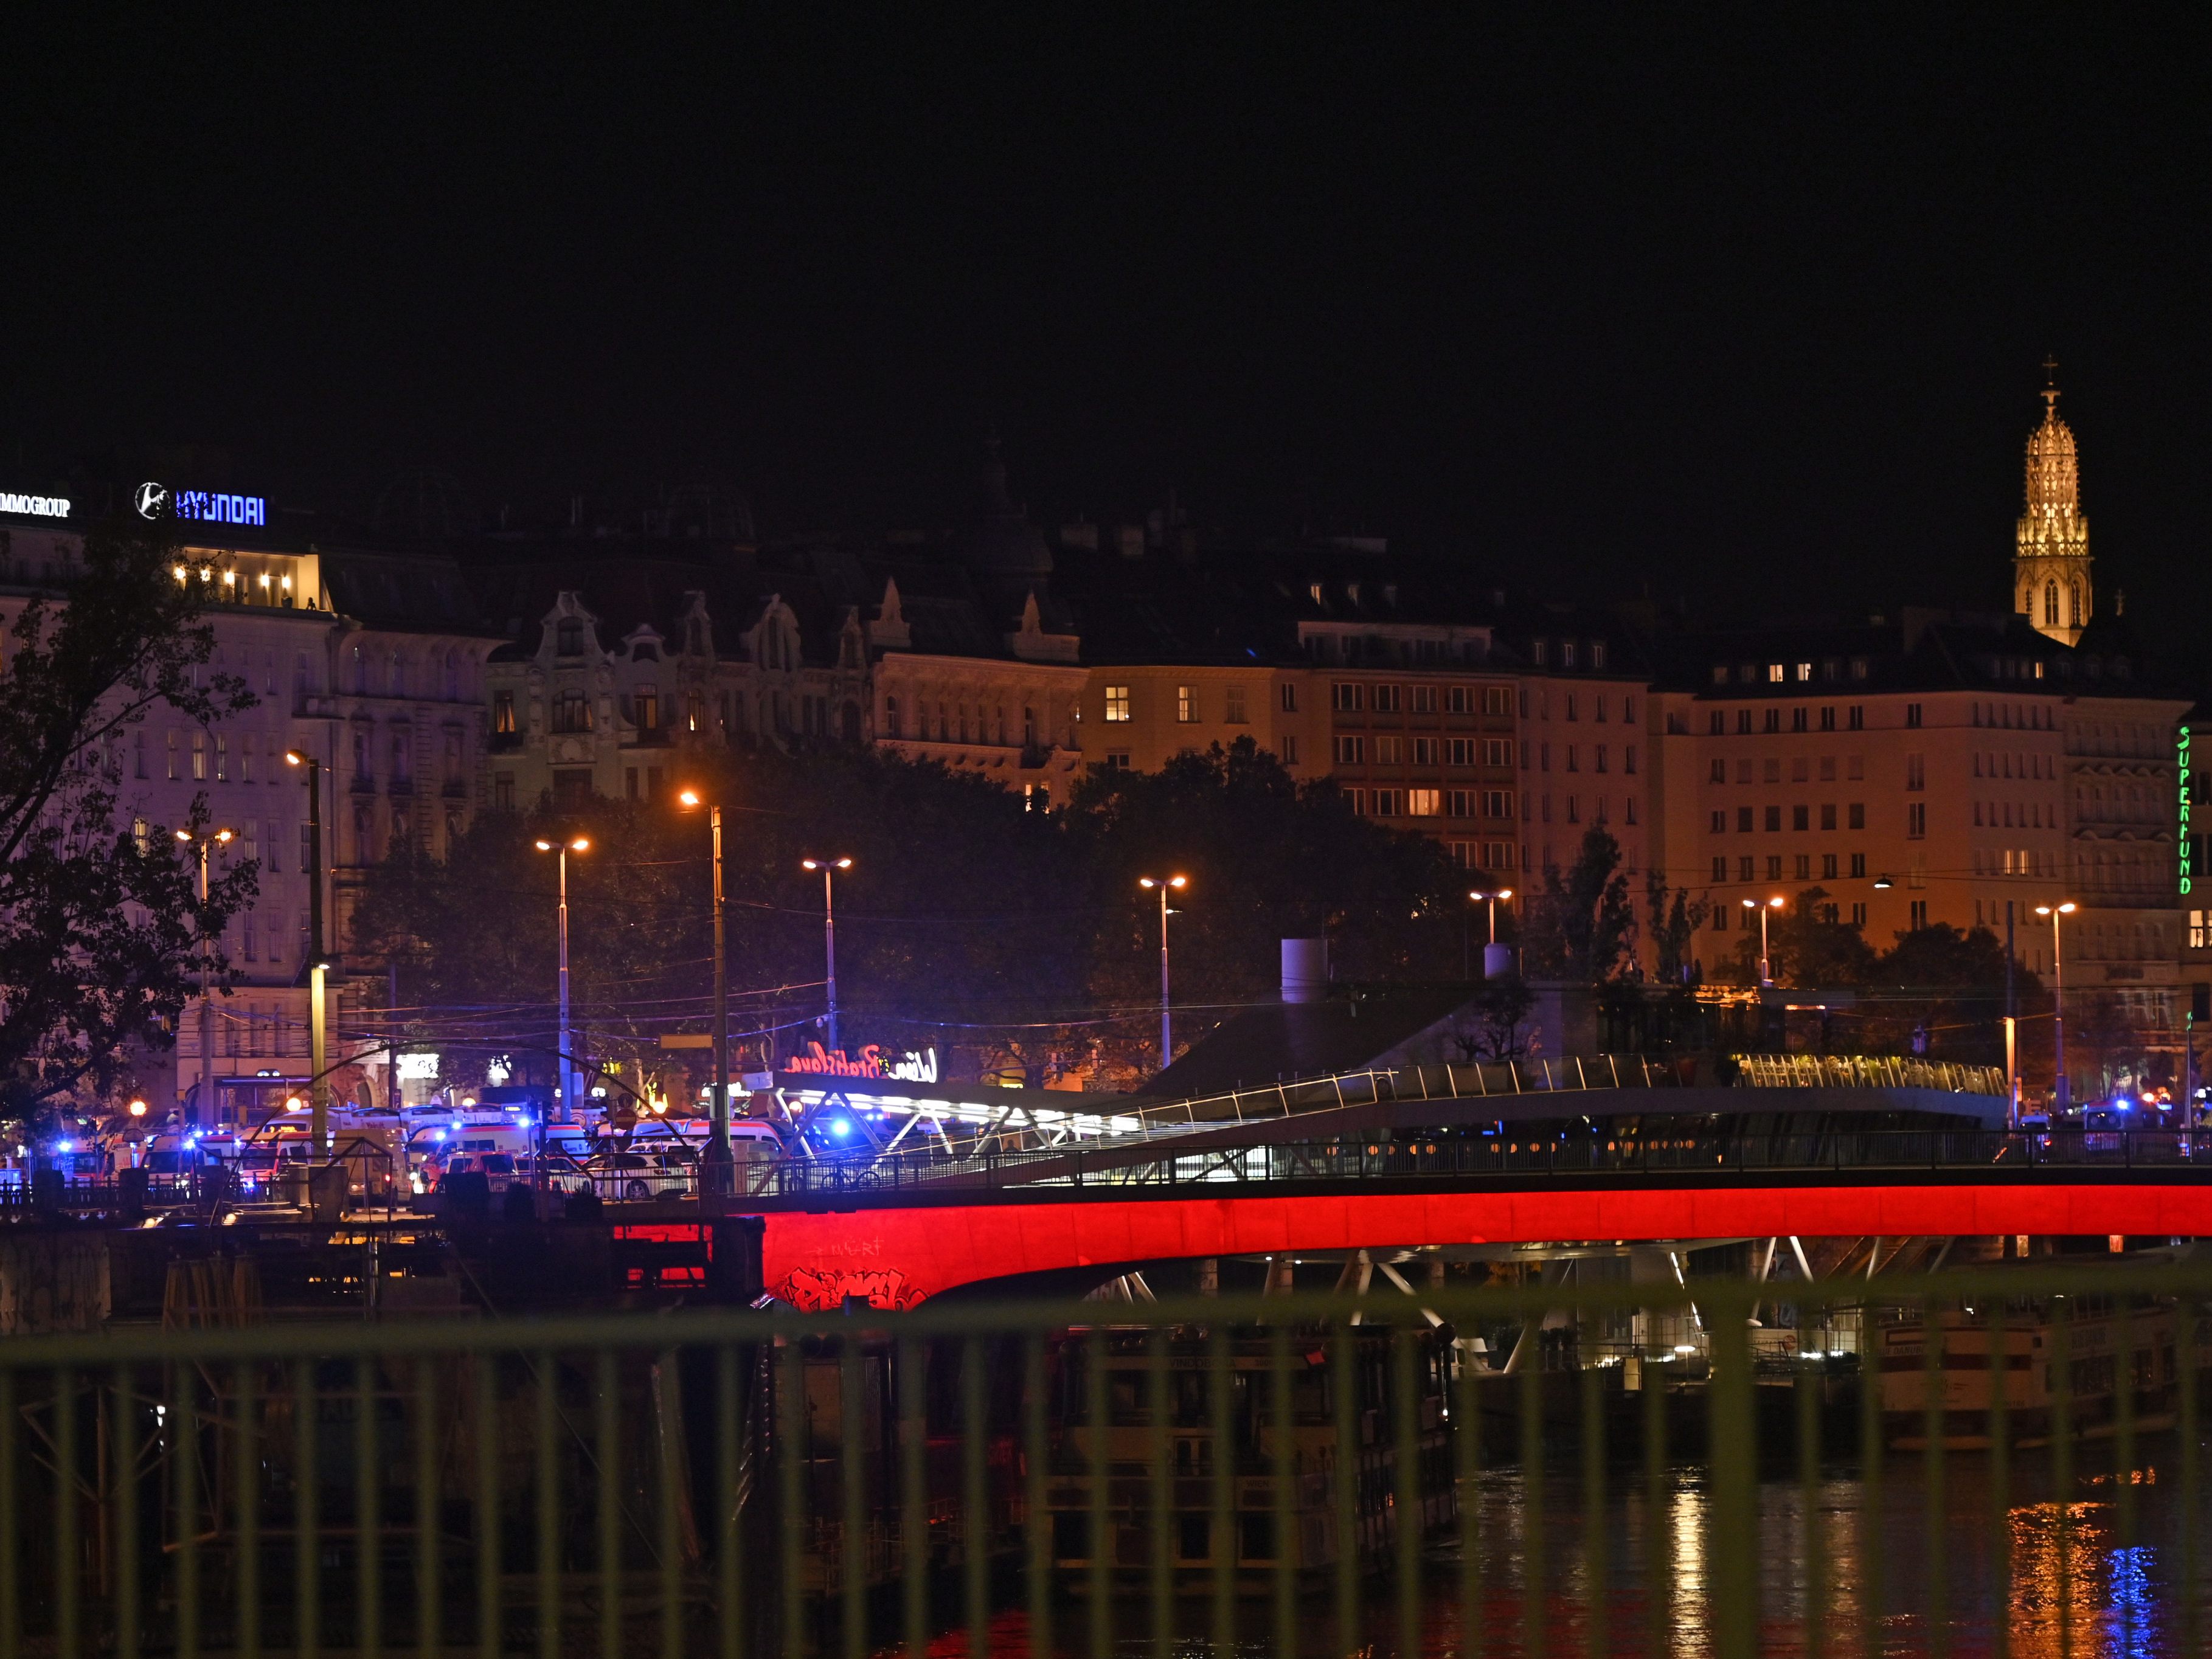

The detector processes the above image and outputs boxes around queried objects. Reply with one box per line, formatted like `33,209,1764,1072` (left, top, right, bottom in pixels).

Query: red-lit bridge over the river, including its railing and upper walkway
732,1062,2212,1307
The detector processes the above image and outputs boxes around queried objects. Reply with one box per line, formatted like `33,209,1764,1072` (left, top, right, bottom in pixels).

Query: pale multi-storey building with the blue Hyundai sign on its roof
0,496,498,1124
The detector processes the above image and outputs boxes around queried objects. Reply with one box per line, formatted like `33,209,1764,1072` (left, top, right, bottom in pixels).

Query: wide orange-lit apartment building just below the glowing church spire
1652,611,2188,1024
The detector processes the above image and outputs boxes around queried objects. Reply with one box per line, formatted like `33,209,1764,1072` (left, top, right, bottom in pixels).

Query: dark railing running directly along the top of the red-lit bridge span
746,1124,2212,1201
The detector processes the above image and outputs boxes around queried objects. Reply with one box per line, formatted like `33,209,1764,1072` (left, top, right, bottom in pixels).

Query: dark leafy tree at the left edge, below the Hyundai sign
0,520,259,1131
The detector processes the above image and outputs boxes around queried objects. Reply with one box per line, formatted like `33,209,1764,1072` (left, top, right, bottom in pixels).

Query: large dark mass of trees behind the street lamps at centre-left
352,741,1458,1092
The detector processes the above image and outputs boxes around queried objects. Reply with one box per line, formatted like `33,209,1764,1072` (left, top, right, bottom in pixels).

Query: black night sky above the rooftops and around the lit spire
0,7,2212,637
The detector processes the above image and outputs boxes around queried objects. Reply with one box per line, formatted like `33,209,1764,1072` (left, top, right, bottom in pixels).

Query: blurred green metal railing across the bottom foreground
0,1266,2212,1659
